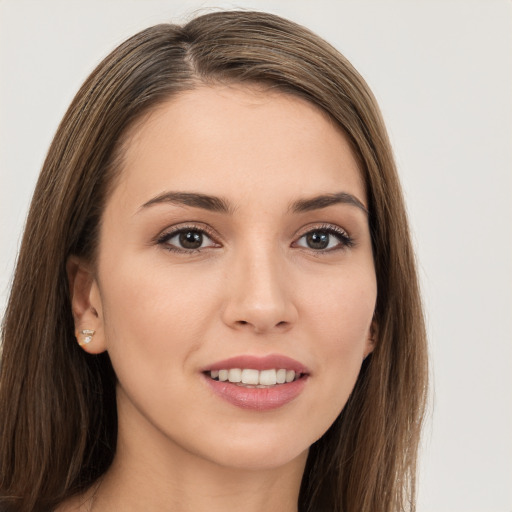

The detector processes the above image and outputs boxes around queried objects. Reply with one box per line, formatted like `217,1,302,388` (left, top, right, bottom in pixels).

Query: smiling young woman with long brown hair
0,12,426,511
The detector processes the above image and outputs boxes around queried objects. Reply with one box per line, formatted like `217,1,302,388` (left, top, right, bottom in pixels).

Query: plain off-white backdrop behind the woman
0,0,512,512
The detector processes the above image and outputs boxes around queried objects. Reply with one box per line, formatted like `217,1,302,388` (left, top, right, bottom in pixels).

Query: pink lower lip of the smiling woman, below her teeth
204,375,307,411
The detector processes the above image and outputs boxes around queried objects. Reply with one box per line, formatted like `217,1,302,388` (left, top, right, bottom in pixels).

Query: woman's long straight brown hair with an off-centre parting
0,11,427,512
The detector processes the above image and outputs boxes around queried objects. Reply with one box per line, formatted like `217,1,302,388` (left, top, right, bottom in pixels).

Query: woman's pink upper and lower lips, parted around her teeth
202,354,310,411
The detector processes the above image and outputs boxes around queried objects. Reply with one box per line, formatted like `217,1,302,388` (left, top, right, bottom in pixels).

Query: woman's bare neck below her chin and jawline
91,394,307,512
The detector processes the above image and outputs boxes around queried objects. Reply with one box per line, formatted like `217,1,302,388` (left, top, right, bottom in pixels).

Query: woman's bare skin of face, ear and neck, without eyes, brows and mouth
65,86,377,512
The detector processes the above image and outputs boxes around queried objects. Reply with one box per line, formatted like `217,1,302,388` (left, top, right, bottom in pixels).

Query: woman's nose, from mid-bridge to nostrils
222,246,298,334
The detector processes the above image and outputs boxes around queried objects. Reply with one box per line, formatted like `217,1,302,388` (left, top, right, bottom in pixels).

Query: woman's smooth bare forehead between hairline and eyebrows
110,85,366,210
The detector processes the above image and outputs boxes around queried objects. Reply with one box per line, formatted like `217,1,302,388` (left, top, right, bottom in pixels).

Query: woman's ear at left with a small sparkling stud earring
66,256,106,354
